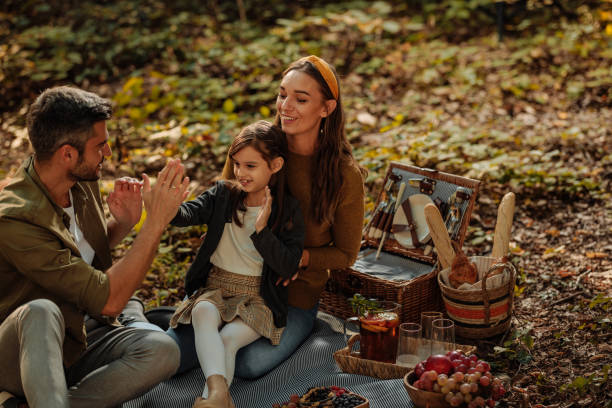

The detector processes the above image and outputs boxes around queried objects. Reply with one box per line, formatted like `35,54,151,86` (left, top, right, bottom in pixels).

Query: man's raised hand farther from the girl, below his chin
106,177,142,230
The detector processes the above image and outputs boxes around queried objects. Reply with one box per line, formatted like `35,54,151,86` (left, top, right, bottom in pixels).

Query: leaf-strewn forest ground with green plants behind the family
0,1,612,408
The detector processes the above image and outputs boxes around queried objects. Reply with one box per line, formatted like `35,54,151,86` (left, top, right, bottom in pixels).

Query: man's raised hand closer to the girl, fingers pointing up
142,159,189,228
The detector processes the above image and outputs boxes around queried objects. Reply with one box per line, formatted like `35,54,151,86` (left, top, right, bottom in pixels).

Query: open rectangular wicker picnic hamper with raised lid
320,162,480,322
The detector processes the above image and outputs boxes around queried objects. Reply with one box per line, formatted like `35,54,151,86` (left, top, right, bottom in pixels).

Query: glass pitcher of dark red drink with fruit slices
359,301,401,364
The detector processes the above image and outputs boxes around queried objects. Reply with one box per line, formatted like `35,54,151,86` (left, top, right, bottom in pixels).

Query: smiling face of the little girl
232,146,283,204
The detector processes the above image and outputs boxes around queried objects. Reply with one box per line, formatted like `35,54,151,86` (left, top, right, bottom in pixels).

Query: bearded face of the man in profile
70,121,111,181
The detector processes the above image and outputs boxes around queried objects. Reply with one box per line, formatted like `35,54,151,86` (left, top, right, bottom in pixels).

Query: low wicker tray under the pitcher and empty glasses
334,334,476,380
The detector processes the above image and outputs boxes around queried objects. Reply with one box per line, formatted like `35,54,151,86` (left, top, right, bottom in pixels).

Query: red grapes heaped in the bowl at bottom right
413,350,506,408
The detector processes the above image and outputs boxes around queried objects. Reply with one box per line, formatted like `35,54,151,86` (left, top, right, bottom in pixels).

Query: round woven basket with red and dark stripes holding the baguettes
438,256,516,339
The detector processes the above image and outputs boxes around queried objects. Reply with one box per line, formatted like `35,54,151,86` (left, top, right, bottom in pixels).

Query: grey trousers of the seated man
0,299,180,408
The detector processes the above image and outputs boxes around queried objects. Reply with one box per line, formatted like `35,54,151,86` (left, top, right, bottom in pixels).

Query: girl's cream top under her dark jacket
210,207,263,276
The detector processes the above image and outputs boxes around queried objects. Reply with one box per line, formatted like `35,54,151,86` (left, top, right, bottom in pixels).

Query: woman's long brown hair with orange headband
274,59,366,223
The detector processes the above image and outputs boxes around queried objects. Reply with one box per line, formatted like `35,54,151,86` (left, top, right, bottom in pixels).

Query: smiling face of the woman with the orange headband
276,70,328,143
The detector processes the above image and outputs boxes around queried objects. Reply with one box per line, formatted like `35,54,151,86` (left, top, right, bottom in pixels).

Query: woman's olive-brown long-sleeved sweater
223,152,365,309
